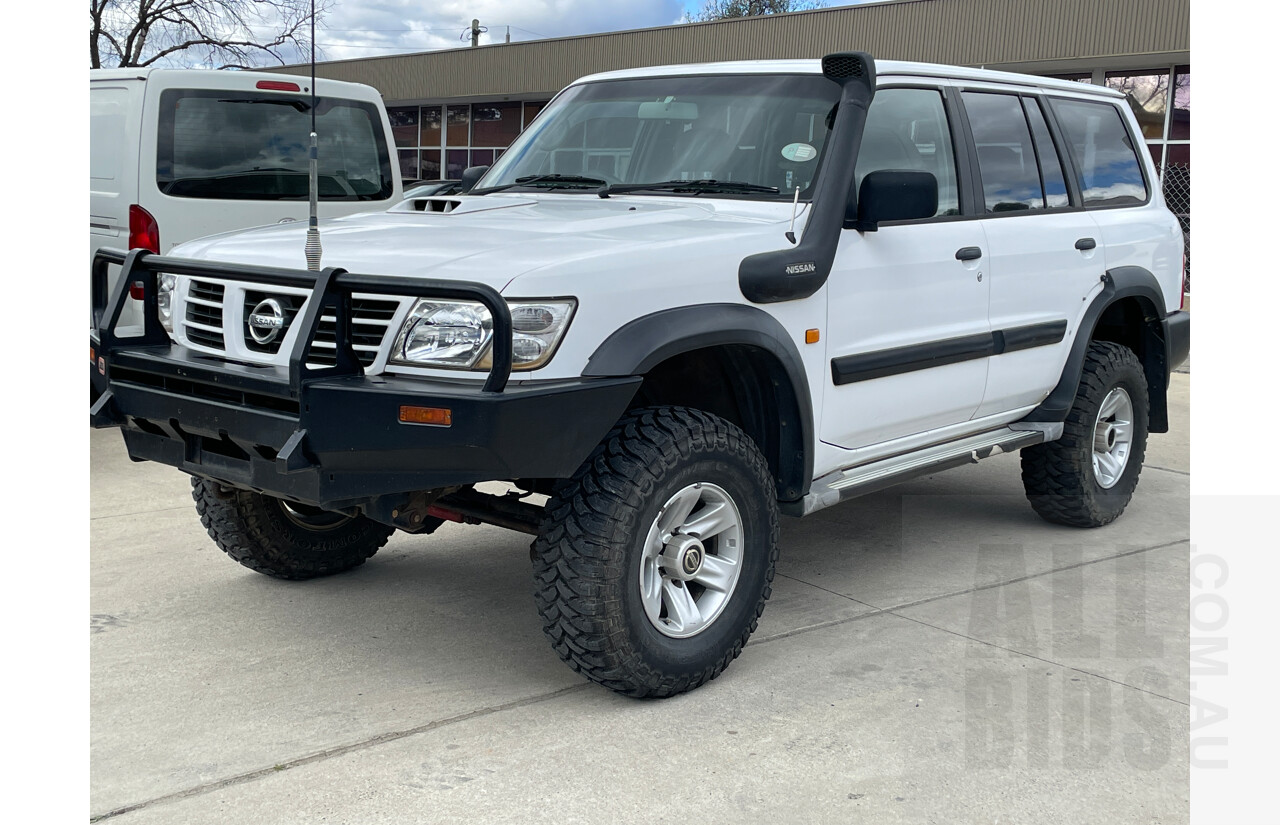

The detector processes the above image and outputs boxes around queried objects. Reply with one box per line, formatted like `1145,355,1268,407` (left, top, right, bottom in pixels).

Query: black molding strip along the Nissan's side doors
831,321,1066,386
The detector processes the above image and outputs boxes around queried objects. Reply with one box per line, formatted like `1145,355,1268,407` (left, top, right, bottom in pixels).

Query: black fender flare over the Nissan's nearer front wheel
582,303,814,500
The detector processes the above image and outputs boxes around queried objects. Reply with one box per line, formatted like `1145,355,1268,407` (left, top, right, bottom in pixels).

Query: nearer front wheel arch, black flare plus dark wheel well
582,304,814,501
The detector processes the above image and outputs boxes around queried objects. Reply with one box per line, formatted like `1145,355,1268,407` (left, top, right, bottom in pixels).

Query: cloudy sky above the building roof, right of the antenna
316,0,773,60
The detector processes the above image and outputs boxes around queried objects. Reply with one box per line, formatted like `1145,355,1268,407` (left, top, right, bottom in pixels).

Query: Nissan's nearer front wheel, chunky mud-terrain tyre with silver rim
532,407,778,697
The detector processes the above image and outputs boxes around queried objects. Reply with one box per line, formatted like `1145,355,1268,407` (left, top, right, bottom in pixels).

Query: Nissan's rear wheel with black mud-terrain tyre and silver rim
1021,342,1149,527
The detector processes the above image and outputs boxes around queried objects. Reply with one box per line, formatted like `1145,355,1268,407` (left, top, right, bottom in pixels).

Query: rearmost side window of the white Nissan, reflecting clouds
1052,98,1147,207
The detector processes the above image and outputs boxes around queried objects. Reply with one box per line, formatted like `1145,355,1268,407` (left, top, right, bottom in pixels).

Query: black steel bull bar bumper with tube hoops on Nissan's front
90,253,641,509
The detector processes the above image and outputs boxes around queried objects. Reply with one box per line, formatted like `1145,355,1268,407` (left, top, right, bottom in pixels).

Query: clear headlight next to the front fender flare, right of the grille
390,298,575,370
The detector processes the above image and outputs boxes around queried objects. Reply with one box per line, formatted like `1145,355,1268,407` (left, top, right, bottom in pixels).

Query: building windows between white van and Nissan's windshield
387,101,547,180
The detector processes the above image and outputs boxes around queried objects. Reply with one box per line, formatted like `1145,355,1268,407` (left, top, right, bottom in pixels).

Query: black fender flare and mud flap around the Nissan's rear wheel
1023,266,1170,432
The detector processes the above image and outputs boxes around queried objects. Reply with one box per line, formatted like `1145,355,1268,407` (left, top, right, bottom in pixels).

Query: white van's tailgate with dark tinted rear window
138,72,402,252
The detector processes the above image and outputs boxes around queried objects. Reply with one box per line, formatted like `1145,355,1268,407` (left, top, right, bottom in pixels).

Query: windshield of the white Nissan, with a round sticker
476,74,840,201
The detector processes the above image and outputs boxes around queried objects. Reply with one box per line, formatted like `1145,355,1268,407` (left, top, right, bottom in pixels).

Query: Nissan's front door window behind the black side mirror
854,88,960,215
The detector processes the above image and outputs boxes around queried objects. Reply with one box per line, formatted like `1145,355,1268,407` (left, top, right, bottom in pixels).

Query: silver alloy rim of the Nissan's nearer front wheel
640,482,744,638
